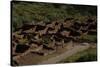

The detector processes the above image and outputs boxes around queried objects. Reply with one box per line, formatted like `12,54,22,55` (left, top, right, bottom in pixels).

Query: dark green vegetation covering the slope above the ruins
12,1,97,31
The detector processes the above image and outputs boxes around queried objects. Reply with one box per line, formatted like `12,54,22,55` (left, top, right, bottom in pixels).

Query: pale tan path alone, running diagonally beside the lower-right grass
38,45,89,64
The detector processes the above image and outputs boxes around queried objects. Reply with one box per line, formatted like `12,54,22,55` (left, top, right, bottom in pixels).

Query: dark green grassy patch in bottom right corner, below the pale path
59,47,97,63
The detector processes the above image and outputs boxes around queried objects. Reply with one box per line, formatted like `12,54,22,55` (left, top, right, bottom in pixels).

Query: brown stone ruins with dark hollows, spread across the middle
11,18,97,65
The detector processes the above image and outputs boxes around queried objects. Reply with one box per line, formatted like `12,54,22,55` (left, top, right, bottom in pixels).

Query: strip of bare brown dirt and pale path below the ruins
18,43,90,65
